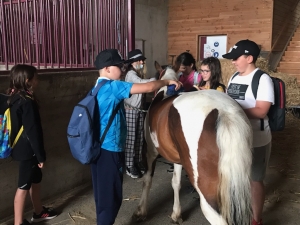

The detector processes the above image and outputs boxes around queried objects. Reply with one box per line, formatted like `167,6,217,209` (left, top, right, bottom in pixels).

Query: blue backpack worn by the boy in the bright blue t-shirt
67,80,120,164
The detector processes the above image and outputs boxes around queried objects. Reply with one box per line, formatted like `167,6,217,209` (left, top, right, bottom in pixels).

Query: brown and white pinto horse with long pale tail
132,62,252,225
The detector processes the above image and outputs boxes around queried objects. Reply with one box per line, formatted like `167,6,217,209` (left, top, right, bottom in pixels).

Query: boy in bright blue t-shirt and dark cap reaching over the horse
91,49,181,225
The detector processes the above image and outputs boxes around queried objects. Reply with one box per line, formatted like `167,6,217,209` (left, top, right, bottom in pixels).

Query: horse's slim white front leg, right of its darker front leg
171,163,183,224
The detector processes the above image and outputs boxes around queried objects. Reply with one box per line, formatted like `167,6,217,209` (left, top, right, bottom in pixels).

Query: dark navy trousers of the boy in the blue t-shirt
91,149,124,225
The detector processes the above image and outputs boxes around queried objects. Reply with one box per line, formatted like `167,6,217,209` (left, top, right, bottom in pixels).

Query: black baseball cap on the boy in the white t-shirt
222,39,260,59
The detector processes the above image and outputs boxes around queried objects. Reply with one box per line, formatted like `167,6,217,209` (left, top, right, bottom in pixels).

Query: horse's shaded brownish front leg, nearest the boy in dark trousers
132,143,158,221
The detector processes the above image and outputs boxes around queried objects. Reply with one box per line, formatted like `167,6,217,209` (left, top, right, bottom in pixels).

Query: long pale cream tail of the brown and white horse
217,110,252,225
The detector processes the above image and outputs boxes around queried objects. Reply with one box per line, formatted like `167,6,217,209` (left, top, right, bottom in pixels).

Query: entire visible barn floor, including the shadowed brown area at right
0,116,300,225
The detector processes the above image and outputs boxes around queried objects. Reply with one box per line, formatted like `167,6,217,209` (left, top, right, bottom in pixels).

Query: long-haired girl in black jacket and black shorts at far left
8,65,57,225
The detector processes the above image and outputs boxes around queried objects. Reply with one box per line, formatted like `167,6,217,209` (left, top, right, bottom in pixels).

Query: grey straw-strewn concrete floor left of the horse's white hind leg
0,158,209,225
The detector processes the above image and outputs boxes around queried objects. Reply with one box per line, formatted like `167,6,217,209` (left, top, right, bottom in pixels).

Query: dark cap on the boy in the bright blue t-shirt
94,49,127,70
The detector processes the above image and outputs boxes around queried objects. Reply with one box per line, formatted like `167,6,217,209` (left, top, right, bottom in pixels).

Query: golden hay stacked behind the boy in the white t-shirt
197,57,300,107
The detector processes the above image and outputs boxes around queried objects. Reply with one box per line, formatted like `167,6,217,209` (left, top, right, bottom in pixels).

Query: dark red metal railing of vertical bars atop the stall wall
0,0,132,70
